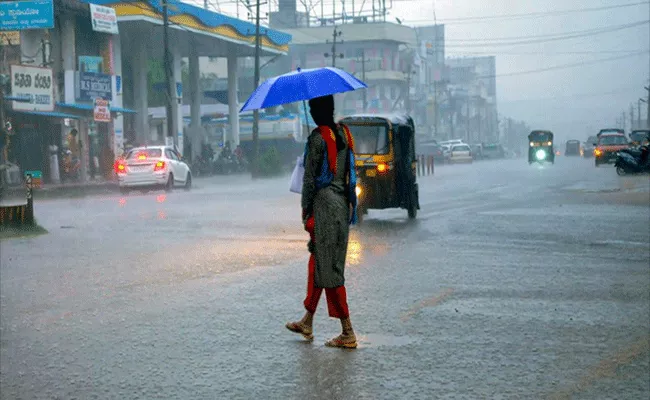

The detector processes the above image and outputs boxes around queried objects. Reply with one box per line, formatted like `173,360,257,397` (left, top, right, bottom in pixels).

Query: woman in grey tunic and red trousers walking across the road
286,96,357,348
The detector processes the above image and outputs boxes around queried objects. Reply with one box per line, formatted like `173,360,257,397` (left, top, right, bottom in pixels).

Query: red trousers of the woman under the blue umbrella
303,217,350,319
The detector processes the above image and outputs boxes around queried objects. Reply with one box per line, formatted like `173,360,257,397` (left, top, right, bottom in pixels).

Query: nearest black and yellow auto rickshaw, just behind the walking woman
339,114,420,222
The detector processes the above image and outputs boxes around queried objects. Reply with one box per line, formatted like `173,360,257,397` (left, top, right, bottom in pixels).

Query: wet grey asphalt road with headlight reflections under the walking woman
0,158,650,399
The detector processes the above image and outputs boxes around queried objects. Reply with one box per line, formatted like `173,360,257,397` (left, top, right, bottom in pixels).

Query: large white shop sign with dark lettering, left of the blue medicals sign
11,65,54,111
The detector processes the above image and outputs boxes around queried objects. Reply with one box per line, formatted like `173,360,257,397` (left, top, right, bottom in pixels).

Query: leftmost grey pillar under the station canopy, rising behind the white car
131,38,150,146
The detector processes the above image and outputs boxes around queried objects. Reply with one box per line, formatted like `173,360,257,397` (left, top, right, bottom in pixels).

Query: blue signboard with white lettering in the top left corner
0,0,54,31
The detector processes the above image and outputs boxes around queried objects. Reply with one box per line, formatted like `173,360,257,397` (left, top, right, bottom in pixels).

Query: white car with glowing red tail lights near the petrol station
115,146,192,193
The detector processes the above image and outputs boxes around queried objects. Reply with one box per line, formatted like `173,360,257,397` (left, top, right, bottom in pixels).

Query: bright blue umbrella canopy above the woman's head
241,67,368,111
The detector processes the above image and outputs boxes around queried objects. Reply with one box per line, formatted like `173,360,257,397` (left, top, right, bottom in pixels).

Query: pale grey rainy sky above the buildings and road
201,0,650,139
